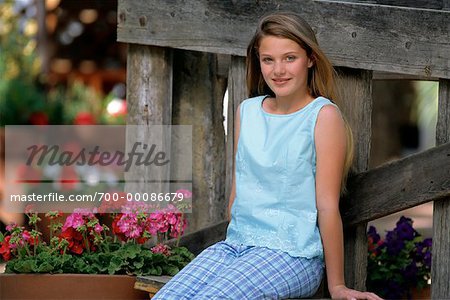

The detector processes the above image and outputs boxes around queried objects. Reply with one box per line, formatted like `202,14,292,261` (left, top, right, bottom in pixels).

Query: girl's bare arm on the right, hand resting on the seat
314,105,381,300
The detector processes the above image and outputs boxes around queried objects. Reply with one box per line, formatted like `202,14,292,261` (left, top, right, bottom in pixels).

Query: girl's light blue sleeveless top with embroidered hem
226,96,334,258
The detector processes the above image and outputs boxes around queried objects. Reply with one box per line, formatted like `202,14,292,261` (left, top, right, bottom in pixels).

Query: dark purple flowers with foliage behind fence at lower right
367,216,432,299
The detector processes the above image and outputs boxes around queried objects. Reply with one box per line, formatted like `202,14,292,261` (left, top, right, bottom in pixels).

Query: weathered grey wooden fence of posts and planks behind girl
117,0,450,299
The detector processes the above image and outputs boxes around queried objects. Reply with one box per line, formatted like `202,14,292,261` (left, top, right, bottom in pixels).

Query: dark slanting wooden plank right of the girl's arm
341,143,450,226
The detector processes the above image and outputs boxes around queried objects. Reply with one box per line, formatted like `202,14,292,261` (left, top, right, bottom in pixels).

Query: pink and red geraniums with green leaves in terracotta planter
0,197,193,275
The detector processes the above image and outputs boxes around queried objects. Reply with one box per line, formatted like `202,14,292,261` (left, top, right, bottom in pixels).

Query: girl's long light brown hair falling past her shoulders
246,12,353,192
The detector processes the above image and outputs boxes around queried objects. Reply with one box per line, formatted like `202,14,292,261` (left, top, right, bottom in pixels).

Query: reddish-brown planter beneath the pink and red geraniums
0,274,149,300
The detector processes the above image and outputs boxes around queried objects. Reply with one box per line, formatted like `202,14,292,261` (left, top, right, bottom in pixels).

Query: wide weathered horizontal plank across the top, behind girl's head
117,0,450,78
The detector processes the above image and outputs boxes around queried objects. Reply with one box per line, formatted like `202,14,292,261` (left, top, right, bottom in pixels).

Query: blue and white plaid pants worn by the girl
152,241,323,300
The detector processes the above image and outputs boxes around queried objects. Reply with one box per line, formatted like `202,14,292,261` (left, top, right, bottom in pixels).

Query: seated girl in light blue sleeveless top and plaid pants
154,12,380,300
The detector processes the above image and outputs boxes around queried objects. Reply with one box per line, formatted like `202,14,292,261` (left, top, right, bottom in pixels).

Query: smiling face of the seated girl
259,35,313,99
